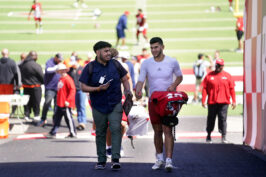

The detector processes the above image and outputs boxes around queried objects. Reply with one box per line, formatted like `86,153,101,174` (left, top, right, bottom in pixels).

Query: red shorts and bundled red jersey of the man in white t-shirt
149,91,188,124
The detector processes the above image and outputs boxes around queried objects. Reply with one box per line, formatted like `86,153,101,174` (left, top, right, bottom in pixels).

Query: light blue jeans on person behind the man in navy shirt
75,90,87,124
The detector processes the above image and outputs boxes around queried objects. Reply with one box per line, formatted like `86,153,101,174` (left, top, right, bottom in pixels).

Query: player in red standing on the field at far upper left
28,0,43,34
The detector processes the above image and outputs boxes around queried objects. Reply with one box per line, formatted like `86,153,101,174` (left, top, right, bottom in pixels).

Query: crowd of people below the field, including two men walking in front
0,37,236,171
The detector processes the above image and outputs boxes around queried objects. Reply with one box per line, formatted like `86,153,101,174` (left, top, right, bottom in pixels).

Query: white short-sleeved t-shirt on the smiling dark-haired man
138,56,182,97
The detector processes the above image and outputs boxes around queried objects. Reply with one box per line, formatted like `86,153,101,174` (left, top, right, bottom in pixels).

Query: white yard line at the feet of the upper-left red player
0,26,235,34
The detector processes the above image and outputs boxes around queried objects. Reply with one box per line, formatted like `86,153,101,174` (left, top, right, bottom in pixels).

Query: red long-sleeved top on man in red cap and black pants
202,71,236,104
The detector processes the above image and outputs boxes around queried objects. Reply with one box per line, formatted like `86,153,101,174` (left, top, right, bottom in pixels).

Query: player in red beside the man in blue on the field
136,9,148,43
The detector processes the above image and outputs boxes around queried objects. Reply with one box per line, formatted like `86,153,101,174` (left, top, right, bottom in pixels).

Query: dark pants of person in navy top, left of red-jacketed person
41,89,57,121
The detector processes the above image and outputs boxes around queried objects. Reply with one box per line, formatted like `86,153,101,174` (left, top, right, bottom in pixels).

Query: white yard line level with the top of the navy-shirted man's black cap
0,37,235,44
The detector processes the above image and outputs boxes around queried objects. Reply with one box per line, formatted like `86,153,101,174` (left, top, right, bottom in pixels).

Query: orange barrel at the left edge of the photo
0,102,10,139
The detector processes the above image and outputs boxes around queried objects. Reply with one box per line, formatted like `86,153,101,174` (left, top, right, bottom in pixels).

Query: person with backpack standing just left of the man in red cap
192,53,210,103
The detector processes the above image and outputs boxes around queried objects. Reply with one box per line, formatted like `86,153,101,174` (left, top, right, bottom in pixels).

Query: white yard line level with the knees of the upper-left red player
0,18,235,25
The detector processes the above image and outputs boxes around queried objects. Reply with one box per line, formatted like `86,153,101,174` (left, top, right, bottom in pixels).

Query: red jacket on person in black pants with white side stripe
57,75,76,108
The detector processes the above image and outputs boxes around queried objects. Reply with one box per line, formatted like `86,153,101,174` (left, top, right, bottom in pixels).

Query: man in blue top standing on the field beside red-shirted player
115,11,129,49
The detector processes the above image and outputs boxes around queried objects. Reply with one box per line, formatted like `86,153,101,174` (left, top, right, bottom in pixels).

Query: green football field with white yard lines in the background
0,0,244,67
